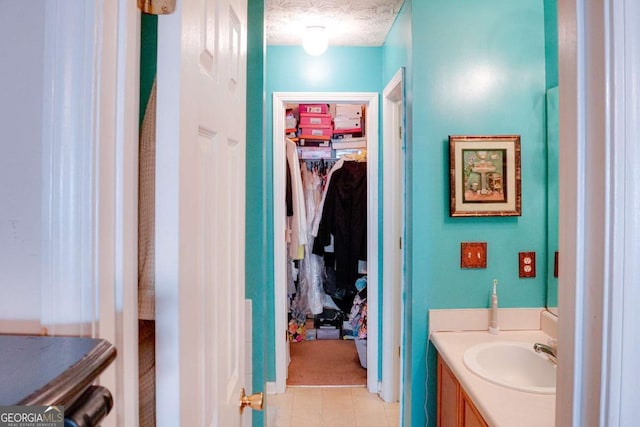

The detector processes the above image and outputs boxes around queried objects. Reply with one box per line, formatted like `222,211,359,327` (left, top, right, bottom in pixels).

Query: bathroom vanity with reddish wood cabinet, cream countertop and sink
430,309,555,427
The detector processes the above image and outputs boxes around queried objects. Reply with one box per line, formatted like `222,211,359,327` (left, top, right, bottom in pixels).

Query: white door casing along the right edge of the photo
556,0,640,426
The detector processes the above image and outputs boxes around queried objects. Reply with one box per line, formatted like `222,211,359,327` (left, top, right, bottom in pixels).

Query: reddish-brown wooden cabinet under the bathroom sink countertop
438,355,489,427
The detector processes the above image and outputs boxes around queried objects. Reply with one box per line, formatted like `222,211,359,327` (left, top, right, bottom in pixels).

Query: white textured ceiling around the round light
265,0,404,46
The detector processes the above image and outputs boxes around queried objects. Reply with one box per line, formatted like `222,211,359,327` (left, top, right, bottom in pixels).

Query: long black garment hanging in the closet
313,161,367,311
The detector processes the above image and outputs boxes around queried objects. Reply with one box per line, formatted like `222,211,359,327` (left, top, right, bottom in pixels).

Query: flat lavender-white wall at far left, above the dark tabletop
0,0,45,320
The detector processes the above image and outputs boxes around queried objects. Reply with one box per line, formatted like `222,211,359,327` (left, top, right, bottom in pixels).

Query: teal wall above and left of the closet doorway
264,46,382,381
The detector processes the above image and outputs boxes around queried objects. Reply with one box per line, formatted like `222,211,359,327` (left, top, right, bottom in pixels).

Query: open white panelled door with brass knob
156,0,248,427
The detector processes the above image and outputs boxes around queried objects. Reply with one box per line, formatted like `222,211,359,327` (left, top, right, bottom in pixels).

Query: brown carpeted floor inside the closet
287,340,367,386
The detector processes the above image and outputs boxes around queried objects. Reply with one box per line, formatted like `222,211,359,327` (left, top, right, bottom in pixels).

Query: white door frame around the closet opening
269,92,379,393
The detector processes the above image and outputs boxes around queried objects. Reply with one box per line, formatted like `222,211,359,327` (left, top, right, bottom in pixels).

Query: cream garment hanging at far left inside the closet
285,138,308,259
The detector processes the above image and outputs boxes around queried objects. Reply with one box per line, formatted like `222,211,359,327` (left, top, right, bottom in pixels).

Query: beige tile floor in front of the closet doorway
267,387,400,427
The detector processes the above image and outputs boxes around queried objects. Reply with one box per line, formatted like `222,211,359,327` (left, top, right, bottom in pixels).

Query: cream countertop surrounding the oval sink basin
431,330,556,427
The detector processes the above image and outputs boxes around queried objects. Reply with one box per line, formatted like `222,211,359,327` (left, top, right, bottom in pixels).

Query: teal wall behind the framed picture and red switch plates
405,0,547,426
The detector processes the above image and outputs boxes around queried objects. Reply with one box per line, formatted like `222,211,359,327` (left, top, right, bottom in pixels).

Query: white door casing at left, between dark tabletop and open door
97,0,140,427
